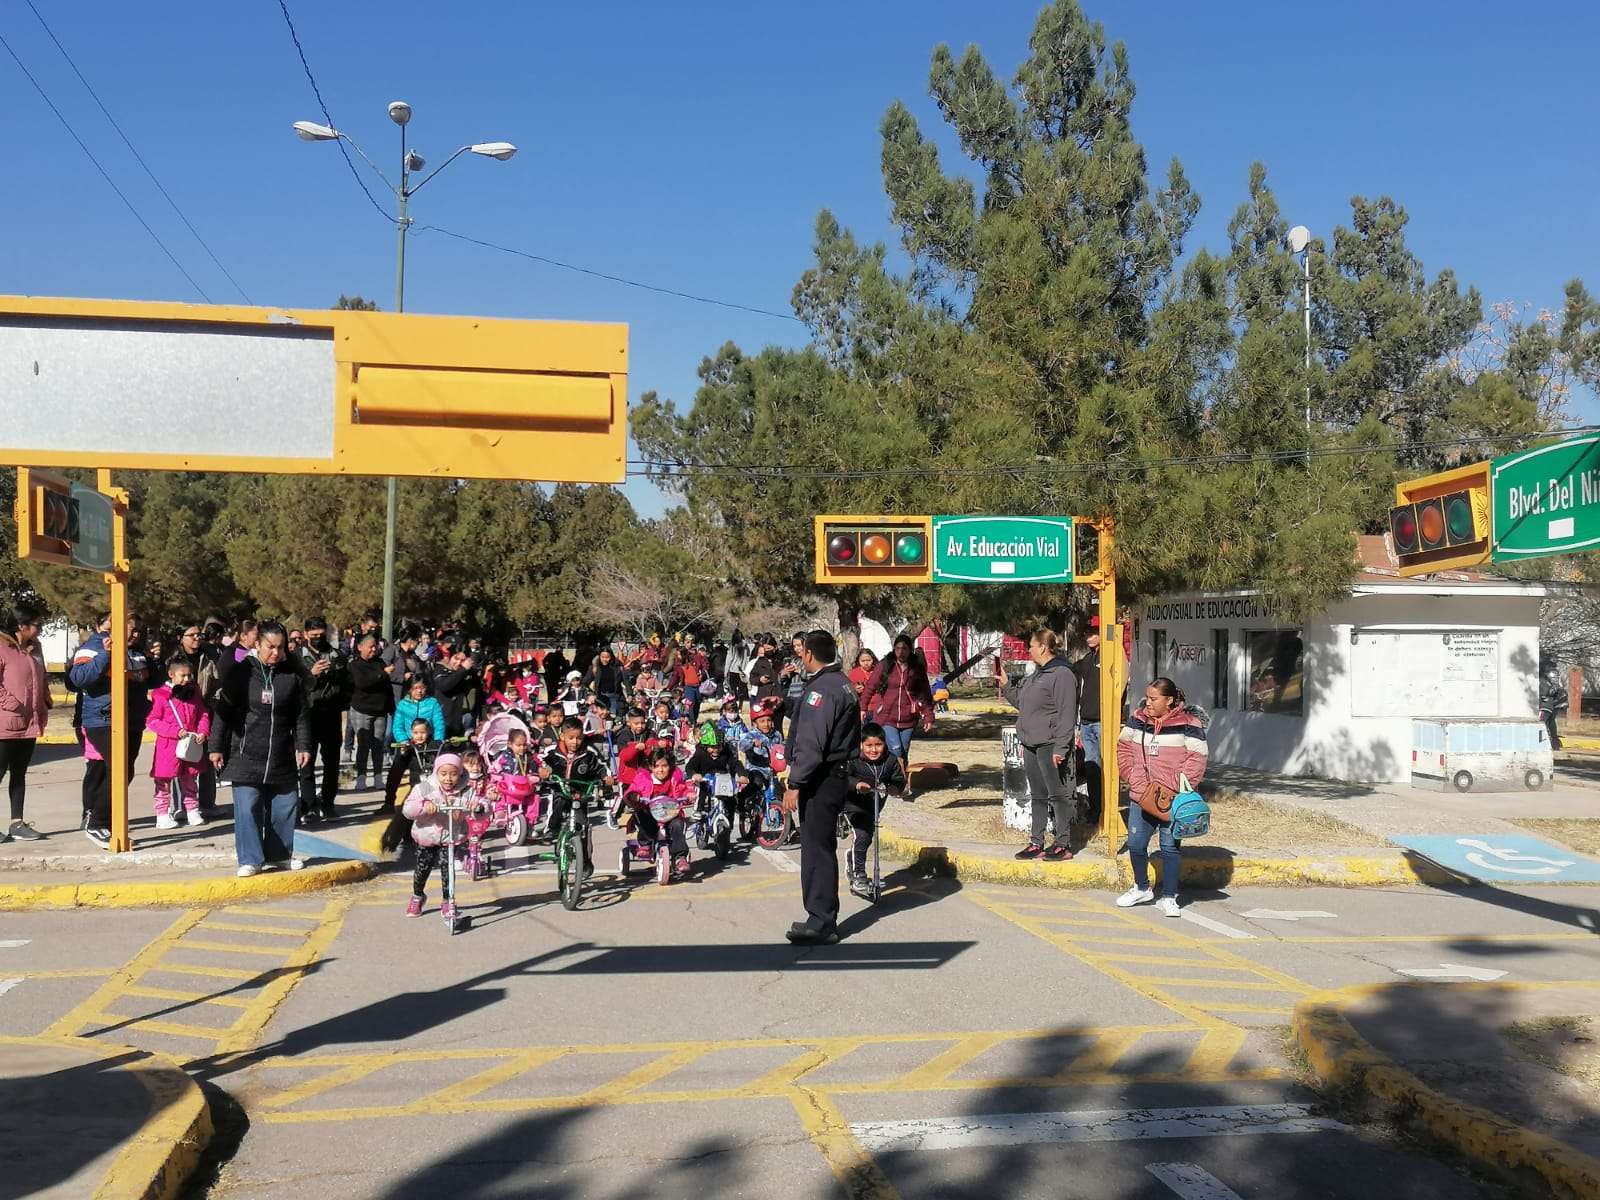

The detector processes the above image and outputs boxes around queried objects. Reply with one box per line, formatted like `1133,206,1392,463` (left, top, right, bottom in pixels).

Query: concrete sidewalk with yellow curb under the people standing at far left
0,746,382,909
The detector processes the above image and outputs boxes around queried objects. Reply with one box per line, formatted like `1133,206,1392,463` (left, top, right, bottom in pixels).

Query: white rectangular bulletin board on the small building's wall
1350,627,1501,717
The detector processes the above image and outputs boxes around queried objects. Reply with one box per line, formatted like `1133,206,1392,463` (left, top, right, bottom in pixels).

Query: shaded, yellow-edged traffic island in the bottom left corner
0,1037,213,1200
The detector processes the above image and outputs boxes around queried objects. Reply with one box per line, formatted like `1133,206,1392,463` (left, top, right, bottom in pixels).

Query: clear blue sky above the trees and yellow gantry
0,0,1600,512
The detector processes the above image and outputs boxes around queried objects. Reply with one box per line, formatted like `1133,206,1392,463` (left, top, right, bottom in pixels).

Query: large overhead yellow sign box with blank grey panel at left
0,296,627,483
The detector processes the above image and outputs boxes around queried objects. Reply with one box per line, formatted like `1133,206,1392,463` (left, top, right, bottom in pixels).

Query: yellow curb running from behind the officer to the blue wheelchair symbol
878,830,1461,888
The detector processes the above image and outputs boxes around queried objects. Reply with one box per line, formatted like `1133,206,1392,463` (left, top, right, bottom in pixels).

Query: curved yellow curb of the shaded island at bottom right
1293,984,1600,1200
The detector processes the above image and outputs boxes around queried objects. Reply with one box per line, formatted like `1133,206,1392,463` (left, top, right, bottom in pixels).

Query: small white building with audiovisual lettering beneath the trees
1128,538,1546,782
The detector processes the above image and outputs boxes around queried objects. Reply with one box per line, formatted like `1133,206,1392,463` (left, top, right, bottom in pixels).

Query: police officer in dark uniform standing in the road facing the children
784,629,861,946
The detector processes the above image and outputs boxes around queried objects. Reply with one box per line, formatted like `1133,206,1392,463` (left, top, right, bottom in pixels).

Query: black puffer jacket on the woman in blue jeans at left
210,658,310,787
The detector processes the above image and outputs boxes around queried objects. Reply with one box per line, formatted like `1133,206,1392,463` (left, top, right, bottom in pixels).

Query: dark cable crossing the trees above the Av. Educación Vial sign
627,426,1600,480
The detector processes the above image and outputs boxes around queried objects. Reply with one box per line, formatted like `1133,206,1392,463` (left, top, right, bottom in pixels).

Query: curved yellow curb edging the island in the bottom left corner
0,1037,214,1200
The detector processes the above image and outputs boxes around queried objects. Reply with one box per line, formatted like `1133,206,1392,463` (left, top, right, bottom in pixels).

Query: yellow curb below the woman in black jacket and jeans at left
0,859,378,912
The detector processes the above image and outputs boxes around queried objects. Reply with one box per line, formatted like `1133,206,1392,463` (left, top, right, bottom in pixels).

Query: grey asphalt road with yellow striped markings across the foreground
0,830,1600,1200
